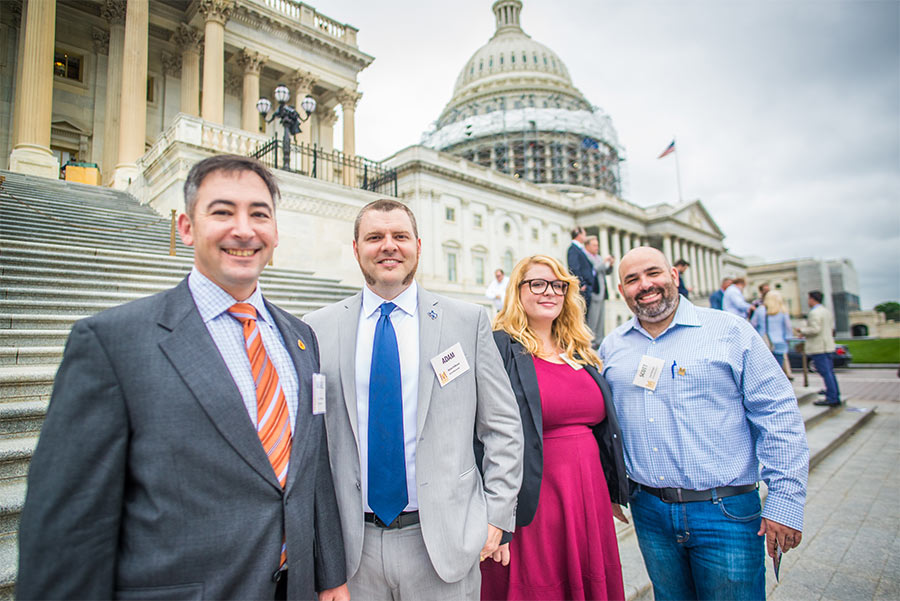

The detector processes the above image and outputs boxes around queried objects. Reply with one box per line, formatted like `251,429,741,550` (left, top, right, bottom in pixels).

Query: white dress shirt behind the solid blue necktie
356,280,419,512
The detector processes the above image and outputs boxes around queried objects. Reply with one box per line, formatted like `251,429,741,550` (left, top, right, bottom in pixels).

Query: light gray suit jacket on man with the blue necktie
304,286,523,582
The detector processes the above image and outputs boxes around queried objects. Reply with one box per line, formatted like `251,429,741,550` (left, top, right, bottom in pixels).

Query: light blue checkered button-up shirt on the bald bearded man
600,297,809,530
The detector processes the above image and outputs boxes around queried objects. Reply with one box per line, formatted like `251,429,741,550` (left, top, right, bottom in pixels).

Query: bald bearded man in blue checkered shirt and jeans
600,247,809,601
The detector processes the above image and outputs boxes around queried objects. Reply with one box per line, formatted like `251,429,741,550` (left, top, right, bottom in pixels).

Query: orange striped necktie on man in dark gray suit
228,303,291,488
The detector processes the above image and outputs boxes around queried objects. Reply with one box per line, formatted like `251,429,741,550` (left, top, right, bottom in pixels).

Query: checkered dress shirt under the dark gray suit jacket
188,267,299,432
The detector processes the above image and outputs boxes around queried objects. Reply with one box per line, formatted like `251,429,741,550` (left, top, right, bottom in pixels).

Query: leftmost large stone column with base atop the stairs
9,0,59,178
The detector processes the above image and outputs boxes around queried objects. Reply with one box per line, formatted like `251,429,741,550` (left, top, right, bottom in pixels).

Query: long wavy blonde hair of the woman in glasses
493,255,603,369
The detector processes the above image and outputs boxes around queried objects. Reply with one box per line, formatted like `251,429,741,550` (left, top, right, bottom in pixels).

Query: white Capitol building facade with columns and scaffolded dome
0,0,745,328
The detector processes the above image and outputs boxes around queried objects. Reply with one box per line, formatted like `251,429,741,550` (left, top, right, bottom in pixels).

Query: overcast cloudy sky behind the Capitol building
310,0,900,309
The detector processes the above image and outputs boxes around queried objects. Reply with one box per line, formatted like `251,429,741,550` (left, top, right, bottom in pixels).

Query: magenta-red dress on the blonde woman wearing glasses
481,357,625,601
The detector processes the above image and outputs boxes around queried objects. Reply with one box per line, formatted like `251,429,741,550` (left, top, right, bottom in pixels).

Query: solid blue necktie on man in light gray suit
368,303,409,524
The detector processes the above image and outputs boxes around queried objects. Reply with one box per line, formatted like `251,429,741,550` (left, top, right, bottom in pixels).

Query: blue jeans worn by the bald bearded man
630,488,766,601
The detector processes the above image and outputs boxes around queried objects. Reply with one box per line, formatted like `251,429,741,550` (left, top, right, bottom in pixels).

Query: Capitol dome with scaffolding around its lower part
422,0,624,196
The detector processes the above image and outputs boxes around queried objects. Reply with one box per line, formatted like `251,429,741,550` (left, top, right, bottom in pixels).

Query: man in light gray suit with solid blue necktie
305,200,523,601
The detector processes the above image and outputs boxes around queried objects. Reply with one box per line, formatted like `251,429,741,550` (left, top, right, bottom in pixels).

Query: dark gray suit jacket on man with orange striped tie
16,279,346,599
